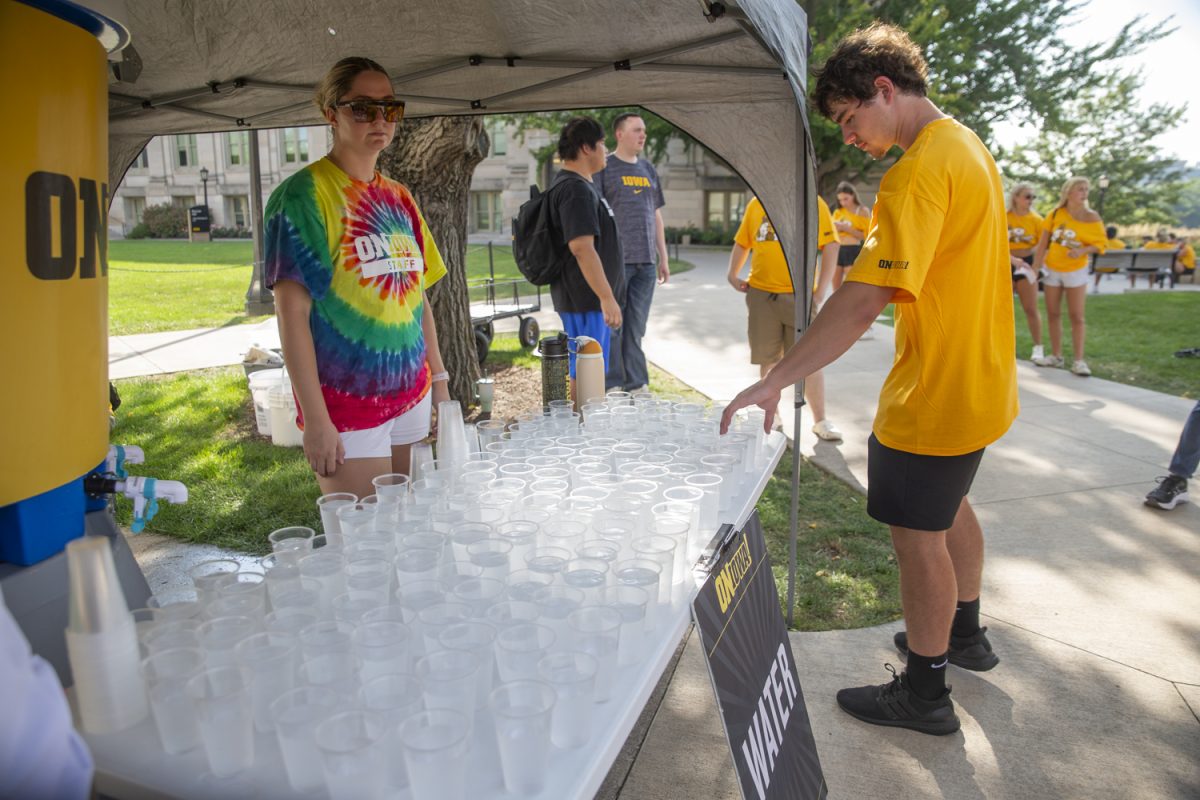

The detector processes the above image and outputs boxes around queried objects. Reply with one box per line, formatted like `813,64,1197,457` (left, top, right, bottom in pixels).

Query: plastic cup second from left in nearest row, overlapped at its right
271,685,352,793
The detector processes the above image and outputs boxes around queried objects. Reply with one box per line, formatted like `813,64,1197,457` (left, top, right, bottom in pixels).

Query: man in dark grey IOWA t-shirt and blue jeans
592,114,671,391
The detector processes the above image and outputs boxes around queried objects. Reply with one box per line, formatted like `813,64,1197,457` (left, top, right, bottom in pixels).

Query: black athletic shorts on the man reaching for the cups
866,433,983,531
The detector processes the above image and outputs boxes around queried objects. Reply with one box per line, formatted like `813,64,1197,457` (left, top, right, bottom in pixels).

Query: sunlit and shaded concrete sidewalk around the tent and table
110,248,1200,800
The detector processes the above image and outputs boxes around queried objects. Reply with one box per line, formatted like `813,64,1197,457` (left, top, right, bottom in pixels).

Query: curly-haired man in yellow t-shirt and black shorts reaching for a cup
721,23,1018,734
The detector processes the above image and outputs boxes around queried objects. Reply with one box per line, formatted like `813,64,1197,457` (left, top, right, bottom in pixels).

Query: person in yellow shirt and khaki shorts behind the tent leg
726,197,841,441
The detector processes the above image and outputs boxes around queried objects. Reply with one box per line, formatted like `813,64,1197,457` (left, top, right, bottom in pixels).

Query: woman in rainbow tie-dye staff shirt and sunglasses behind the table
265,58,449,497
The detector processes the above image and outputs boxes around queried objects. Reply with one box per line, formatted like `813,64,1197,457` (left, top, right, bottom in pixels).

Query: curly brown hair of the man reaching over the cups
812,22,929,116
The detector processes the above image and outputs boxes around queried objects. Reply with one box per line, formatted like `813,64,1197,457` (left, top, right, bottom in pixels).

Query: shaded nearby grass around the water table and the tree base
113,335,900,630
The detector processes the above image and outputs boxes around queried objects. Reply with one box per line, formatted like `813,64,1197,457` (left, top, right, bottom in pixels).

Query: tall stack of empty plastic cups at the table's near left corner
66,536,149,733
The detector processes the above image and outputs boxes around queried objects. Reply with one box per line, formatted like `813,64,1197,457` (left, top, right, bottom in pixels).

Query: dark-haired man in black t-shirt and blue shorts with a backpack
550,116,625,396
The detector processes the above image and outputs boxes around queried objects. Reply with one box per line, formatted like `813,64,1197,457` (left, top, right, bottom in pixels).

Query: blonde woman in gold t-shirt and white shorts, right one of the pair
1033,175,1109,378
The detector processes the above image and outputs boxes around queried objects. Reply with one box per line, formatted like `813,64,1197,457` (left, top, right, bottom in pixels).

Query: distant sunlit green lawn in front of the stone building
108,239,692,336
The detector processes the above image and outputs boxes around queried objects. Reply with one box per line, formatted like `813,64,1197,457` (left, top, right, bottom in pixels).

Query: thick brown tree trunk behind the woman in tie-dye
379,116,488,411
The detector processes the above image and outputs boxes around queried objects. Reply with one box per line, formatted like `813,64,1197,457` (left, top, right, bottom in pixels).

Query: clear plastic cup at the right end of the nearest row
491,680,557,796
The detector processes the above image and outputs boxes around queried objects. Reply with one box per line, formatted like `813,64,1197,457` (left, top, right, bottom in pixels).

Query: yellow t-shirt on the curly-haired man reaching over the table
846,119,1018,456
